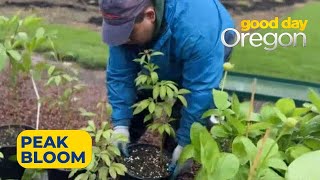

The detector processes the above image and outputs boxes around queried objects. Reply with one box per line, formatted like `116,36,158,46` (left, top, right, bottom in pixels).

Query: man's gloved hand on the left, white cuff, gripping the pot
113,126,130,157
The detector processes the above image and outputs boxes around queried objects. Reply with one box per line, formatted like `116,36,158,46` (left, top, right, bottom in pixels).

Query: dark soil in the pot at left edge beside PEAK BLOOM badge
0,127,26,147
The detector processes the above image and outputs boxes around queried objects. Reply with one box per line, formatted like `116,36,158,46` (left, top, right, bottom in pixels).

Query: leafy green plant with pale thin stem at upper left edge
0,15,55,129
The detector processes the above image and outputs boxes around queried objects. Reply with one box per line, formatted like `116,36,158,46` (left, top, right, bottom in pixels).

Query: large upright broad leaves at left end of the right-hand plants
178,123,240,180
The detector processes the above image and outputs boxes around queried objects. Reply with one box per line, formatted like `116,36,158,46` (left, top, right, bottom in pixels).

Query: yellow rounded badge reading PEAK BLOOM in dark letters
17,130,92,169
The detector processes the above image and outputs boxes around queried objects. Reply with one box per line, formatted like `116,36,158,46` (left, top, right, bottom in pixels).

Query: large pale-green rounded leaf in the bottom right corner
286,151,320,180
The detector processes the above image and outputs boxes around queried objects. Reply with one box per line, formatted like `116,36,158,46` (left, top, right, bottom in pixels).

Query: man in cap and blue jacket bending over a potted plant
100,0,234,177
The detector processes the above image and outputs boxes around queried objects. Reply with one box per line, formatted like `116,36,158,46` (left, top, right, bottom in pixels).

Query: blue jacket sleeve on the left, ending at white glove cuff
106,46,138,126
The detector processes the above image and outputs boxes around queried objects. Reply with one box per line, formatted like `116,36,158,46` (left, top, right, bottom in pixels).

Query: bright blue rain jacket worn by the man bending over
107,0,234,146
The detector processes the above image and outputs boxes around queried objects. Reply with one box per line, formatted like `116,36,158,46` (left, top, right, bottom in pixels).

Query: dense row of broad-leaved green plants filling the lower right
179,64,320,180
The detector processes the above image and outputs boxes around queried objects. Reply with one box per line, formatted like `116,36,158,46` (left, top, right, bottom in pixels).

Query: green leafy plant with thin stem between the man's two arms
132,50,190,167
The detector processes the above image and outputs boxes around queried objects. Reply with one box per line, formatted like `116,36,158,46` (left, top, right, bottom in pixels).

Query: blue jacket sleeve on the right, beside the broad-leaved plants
177,36,224,146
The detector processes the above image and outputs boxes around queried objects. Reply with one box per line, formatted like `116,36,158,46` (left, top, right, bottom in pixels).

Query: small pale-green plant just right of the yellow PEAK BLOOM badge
69,103,128,180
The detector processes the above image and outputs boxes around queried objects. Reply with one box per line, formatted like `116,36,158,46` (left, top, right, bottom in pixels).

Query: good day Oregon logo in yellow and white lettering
221,17,308,51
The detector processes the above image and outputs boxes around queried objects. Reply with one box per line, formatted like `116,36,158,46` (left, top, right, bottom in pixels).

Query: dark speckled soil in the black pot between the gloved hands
124,145,170,179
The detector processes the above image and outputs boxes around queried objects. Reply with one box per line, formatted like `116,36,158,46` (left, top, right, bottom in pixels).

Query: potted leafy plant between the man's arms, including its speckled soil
125,50,190,178
